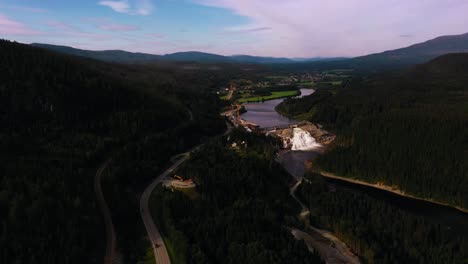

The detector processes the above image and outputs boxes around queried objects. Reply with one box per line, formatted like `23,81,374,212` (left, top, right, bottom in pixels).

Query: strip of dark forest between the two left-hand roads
103,93,225,263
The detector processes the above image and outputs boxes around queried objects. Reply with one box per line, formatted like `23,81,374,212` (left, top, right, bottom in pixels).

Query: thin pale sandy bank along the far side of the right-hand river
320,171,468,214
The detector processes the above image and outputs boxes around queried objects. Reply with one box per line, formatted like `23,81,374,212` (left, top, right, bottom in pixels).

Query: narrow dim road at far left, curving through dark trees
94,159,116,264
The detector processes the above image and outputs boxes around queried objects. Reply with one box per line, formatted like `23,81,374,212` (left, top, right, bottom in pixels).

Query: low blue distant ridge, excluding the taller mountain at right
31,43,344,64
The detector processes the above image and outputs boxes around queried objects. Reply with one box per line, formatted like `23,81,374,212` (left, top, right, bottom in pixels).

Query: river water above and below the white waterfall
242,89,468,235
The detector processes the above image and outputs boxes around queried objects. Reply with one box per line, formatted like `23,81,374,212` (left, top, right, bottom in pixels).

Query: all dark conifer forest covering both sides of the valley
0,37,468,263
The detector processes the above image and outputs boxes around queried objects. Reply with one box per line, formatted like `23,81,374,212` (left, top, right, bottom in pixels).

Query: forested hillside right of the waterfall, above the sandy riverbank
278,54,468,208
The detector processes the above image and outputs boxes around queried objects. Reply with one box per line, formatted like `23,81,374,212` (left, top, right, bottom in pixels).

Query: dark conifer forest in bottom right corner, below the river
298,174,468,264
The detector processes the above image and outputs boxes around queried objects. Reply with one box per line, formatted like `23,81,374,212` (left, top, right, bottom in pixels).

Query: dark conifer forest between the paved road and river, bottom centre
152,130,321,263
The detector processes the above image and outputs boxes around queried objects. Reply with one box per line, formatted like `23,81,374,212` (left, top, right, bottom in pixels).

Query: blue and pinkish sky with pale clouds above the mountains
0,0,468,58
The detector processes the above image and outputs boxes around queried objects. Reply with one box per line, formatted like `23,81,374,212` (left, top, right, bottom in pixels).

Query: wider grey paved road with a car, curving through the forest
140,153,189,264
